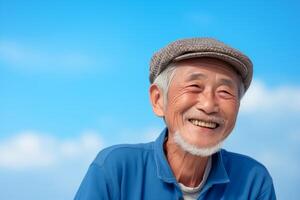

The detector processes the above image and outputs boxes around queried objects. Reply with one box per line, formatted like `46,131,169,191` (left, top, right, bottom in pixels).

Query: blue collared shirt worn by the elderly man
75,129,276,200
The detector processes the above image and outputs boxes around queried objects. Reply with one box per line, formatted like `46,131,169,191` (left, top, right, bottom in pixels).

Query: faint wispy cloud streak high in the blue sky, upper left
0,41,94,72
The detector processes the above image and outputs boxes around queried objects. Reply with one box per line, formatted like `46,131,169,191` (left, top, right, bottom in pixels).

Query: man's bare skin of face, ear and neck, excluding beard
150,58,240,186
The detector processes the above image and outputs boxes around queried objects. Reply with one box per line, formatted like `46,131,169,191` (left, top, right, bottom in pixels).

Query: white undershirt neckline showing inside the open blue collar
179,157,211,200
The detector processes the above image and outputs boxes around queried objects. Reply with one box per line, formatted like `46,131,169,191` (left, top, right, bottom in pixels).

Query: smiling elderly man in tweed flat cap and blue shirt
75,38,276,200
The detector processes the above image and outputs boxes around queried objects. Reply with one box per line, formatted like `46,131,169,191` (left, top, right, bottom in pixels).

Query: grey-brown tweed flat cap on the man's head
150,38,253,91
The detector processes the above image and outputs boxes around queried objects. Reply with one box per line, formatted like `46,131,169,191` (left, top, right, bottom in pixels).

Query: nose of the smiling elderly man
197,91,219,114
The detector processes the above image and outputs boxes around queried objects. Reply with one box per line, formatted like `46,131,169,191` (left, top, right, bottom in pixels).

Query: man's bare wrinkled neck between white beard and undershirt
164,138,208,187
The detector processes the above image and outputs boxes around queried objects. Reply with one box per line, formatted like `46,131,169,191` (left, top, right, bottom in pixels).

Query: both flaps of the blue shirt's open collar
154,128,230,186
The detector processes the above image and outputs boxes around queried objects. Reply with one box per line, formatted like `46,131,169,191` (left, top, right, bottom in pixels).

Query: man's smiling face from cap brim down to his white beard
163,58,240,148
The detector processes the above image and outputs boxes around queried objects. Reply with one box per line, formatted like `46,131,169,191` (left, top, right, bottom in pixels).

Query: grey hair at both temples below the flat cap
153,62,245,106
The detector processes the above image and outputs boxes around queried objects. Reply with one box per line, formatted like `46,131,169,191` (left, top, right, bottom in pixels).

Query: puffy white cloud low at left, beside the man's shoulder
0,131,103,169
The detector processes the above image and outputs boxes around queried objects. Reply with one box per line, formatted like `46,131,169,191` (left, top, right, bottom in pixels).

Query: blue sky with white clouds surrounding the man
0,0,300,200
